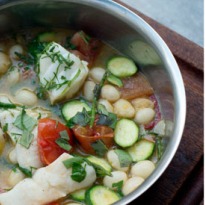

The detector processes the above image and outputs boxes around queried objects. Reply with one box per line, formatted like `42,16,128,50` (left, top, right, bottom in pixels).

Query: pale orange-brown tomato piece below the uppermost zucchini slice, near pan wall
119,73,153,100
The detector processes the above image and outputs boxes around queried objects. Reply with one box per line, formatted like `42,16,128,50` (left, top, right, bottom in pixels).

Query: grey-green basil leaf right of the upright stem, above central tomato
96,112,117,129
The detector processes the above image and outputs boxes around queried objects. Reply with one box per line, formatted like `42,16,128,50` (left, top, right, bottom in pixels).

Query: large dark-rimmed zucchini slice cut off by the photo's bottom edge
85,185,121,205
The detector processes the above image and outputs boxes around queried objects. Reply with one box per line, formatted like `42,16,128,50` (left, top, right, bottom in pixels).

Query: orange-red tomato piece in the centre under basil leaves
73,125,114,154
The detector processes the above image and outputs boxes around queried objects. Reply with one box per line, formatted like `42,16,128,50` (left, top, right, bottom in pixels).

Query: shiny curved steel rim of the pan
0,0,186,205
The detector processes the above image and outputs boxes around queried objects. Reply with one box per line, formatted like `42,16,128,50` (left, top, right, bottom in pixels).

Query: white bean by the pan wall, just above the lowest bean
130,160,155,179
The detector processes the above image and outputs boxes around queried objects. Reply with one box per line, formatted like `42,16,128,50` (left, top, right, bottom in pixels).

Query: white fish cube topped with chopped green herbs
38,42,88,104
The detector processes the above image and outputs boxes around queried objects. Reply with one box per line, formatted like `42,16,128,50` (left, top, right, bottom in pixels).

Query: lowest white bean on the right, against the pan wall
122,177,144,195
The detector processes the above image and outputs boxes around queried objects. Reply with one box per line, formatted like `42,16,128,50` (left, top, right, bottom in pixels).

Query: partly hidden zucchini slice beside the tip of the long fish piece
87,155,112,177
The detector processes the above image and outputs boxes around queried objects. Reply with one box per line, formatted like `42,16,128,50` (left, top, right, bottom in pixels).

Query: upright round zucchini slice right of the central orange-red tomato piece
114,119,139,147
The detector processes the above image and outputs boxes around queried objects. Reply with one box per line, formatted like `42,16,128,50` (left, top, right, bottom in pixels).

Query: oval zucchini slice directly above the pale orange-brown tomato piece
107,56,137,78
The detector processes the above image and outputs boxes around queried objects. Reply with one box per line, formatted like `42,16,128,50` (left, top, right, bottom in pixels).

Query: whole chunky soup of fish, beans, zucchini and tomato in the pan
0,29,164,205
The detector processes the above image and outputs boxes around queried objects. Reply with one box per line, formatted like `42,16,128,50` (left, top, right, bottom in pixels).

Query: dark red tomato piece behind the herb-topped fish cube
71,31,102,64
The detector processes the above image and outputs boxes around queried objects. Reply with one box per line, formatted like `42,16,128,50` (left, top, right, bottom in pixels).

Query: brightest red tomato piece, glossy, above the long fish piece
37,118,73,165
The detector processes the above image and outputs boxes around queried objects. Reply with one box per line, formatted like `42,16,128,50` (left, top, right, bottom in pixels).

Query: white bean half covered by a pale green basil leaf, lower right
107,150,129,172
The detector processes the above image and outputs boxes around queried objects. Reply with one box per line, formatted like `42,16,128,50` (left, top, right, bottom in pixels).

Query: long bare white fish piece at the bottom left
0,153,96,205
